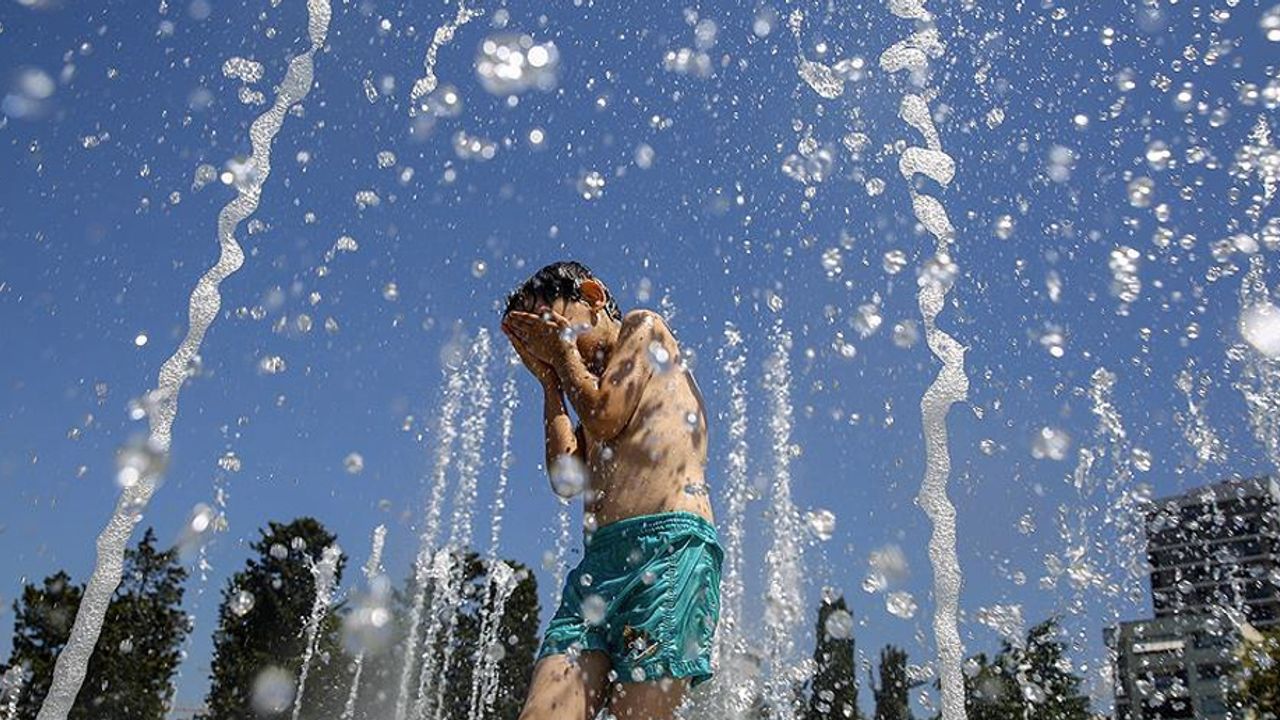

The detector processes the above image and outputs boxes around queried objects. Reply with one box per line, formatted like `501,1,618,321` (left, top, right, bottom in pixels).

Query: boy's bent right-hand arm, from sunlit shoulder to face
552,310,677,441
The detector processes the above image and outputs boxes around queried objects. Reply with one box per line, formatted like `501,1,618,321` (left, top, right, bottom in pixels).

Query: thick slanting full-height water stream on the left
37,0,332,720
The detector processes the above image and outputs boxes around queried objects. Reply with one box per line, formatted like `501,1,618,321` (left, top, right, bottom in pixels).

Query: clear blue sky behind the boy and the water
0,0,1276,705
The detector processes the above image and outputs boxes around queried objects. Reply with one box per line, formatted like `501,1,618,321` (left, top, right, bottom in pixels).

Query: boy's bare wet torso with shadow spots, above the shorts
586,363,712,527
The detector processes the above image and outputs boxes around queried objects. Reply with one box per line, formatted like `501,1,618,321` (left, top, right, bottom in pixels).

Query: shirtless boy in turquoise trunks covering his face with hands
502,263,723,720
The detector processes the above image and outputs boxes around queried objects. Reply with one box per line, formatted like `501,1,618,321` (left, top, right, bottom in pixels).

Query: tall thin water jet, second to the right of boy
764,319,804,720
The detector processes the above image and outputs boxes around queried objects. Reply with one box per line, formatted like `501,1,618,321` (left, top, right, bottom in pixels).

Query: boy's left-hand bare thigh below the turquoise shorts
520,651,609,720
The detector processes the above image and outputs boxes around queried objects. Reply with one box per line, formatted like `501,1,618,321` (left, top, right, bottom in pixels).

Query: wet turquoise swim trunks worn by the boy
538,512,724,685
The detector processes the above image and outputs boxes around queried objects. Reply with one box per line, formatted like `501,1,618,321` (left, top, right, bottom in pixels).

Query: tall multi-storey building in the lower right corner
1105,478,1280,720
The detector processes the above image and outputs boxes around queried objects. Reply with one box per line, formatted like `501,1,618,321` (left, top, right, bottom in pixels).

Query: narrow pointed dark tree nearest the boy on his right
804,596,861,720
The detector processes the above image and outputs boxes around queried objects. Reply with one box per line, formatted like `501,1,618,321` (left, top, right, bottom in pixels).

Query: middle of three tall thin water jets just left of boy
419,328,493,715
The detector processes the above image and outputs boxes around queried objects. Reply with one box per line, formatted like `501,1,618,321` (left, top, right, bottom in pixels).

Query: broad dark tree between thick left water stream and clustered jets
206,518,349,720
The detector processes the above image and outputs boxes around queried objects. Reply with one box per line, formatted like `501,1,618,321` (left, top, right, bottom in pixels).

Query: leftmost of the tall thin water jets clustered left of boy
396,356,466,720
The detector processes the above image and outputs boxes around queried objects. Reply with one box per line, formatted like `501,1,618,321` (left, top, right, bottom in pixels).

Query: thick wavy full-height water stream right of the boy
879,0,969,720
